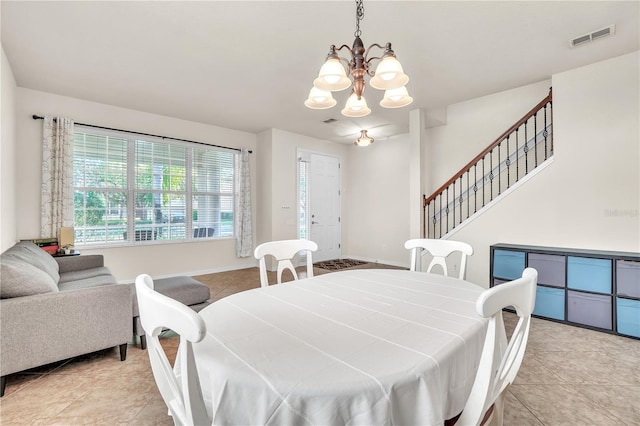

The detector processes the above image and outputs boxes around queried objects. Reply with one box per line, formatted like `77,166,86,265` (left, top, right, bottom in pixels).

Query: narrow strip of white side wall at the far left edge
0,48,18,252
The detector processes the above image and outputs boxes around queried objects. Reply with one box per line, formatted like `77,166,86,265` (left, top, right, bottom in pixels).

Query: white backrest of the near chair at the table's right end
456,268,538,426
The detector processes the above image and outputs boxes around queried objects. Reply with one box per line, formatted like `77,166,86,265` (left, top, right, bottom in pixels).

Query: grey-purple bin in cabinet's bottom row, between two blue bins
567,291,613,330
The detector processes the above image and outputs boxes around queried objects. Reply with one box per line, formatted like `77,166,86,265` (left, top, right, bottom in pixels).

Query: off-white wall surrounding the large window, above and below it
13,86,256,281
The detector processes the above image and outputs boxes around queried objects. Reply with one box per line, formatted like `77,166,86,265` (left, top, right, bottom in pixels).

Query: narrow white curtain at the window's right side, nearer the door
234,149,253,257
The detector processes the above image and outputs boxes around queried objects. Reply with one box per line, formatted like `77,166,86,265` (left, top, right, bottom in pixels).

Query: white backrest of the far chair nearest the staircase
404,238,473,280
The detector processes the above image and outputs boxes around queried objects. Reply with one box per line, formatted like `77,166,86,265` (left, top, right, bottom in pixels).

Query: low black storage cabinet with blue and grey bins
489,244,640,339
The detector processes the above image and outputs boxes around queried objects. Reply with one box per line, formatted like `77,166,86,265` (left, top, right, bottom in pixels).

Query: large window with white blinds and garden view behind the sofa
73,126,235,245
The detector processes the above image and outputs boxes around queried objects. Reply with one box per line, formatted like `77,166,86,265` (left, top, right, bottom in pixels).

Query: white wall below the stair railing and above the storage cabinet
439,52,640,286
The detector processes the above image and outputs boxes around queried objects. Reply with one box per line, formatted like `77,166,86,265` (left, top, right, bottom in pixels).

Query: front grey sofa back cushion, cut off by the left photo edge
0,253,58,299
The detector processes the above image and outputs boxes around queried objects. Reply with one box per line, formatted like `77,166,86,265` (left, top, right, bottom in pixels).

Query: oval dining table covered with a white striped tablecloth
194,269,487,425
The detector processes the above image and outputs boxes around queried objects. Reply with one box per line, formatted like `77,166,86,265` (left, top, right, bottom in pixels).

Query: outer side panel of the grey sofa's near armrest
0,284,132,376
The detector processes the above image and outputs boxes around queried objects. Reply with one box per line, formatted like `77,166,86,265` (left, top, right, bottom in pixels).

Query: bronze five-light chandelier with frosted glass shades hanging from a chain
304,0,413,117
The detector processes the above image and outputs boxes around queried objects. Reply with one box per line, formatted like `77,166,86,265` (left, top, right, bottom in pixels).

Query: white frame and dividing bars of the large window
73,124,238,249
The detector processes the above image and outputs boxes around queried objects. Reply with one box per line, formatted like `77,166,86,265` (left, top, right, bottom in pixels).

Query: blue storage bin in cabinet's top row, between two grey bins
567,256,611,293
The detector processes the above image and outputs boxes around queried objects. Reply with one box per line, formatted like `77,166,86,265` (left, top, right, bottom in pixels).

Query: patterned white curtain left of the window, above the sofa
40,117,74,238
